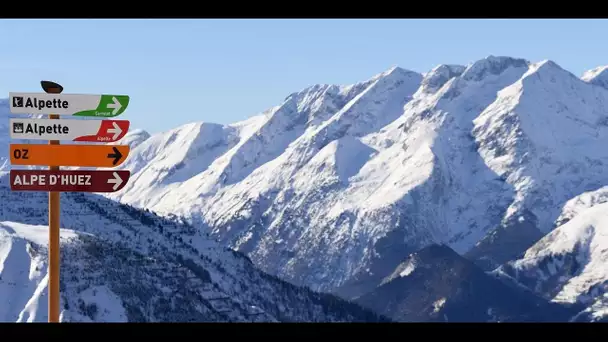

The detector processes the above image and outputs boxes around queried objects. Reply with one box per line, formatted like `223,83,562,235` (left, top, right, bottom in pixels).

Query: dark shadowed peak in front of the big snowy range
357,245,581,322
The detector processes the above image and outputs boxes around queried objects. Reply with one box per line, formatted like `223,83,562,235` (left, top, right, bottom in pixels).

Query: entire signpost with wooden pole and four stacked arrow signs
9,81,131,322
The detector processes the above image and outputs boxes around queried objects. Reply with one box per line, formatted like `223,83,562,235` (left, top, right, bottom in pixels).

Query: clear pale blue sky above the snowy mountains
0,19,608,133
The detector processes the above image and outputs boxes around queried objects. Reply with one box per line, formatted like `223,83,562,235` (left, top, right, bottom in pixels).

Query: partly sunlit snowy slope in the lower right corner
496,194,608,320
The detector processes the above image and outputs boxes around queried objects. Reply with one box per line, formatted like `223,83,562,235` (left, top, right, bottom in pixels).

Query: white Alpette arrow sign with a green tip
9,93,129,117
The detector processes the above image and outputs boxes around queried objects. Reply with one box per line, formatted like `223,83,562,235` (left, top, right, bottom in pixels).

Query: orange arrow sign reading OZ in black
10,144,129,167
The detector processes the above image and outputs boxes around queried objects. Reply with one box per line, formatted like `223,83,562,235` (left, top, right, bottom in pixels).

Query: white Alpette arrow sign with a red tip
10,119,129,142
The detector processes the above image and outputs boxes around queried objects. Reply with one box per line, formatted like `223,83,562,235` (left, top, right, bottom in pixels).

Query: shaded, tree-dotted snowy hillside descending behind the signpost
0,177,388,322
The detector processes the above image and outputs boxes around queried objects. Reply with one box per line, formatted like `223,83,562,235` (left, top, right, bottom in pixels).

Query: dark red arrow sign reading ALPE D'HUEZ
10,170,131,192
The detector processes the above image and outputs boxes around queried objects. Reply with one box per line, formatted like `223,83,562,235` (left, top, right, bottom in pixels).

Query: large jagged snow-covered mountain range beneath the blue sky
89,56,608,297
